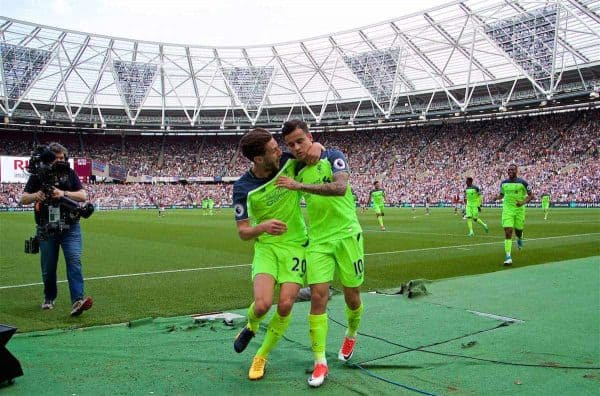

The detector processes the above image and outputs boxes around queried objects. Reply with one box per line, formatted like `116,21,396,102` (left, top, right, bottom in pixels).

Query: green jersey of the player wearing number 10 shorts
295,150,362,244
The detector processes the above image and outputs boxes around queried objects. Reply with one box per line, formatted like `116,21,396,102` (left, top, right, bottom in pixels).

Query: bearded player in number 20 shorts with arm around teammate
233,128,322,380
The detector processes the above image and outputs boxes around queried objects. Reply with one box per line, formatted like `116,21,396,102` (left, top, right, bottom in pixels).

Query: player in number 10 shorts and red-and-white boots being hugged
277,120,364,387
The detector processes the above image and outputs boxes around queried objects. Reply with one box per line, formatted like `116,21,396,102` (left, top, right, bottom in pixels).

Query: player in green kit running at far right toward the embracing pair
494,164,533,265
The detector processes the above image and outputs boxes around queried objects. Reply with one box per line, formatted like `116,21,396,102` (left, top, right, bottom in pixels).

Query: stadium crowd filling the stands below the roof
0,110,600,206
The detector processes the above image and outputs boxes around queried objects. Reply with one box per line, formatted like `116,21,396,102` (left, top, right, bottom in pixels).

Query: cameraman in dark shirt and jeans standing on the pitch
21,143,93,316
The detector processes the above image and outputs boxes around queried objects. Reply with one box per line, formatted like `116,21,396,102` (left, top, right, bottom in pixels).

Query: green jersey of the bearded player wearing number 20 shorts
246,160,306,243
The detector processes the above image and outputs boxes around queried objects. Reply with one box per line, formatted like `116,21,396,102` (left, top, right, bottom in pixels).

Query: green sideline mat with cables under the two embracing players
0,257,600,396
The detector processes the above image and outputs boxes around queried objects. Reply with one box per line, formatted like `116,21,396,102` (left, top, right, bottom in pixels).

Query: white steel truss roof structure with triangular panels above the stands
0,0,600,129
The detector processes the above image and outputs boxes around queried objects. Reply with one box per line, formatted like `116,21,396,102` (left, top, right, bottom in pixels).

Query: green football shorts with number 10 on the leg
306,233,365,287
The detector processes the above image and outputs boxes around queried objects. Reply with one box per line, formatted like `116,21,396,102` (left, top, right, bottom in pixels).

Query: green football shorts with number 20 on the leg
252,242,306,286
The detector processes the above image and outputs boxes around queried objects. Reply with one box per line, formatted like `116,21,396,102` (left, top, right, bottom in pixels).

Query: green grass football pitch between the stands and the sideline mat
0,208,600,331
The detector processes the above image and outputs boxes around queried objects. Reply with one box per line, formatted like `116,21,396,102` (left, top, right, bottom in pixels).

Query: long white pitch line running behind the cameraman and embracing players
0,232,600,290
